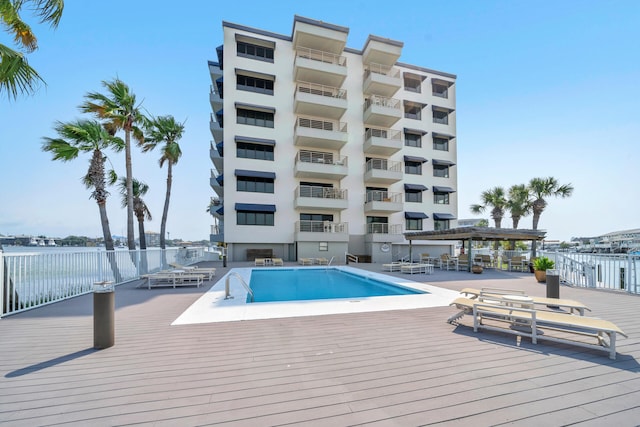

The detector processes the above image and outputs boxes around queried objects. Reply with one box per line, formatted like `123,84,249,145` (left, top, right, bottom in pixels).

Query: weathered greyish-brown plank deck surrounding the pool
0,264,640,427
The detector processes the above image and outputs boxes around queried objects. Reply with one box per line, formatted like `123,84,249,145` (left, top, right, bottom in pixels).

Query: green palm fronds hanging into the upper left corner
0,0,64,99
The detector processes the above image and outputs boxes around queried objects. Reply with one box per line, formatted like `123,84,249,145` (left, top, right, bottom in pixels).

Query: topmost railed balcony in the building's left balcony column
293,47,347,87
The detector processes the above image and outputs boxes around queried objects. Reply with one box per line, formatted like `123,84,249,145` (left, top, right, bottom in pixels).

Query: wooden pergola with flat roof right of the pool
404,227,547,271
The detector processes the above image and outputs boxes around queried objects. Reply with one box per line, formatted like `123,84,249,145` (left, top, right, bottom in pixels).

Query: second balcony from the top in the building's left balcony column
294,83,347,120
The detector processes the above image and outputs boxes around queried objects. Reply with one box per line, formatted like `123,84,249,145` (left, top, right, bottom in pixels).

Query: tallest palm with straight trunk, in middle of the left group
80,78,146,250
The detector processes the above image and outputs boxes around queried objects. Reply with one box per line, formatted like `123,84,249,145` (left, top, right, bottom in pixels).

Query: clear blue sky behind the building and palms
0,0,640,240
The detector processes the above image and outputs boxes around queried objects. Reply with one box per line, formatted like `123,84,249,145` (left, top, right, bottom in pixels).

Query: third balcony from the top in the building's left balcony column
294,117,348,151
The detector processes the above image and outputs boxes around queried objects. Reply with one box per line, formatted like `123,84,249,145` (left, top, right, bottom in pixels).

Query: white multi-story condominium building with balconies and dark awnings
209,16,458,262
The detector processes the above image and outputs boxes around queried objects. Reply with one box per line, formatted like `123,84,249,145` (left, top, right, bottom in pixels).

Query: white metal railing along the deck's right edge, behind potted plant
540,251,640,294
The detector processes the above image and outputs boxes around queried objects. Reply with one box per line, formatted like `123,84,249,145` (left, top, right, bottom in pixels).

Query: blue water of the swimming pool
247,268,426,302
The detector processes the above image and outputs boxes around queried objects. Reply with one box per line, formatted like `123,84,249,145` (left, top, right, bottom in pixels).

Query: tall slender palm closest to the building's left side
142,116,184,249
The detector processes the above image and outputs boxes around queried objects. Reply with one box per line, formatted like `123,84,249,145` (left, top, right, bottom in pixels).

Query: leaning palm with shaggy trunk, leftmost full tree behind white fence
42,120,124,282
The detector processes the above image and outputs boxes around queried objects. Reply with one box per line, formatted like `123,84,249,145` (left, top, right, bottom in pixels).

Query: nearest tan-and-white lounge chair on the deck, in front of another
449,296,627,359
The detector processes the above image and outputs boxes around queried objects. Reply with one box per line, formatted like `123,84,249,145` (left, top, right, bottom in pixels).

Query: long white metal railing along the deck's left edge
0,248,205,316
